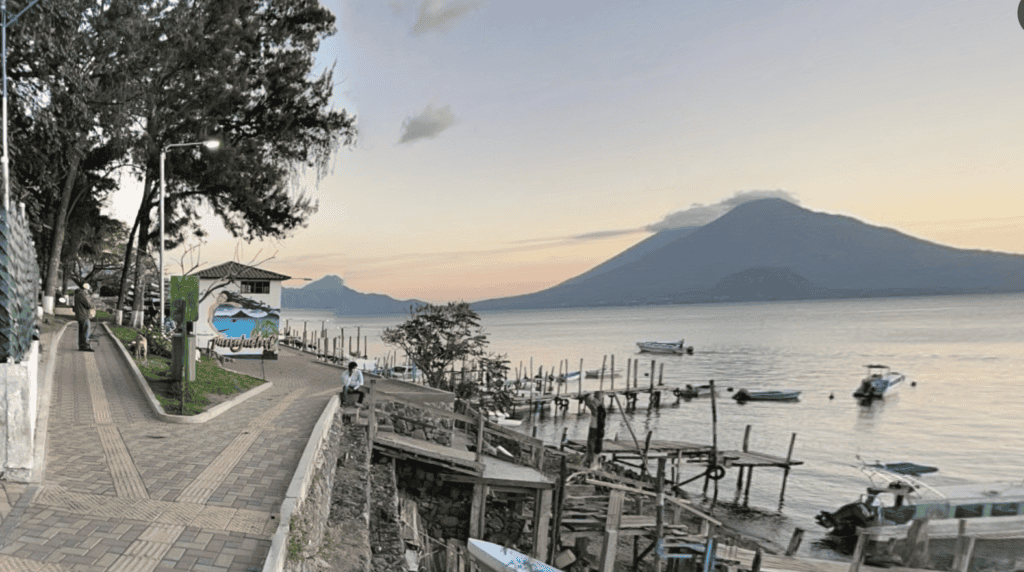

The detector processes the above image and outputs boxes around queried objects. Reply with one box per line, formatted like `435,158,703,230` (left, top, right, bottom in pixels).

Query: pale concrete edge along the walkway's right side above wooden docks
263,393,341,572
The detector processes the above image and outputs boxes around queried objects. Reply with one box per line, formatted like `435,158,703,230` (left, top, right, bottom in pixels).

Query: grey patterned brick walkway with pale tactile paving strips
0,323,339,572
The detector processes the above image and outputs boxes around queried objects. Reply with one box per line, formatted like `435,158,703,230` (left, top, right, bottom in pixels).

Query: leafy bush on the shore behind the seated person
381,302,487,391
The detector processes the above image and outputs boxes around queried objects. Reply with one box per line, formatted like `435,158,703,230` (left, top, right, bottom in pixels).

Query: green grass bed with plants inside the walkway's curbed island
111,325,264,415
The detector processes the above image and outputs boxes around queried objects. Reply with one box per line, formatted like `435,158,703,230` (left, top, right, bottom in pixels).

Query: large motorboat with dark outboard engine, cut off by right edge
814,465,1024,537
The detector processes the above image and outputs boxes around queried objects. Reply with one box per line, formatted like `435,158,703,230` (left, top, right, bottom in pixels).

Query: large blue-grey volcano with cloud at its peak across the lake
473,199,1024,310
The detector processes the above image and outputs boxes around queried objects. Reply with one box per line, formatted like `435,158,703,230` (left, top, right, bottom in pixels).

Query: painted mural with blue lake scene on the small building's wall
207,291,281,359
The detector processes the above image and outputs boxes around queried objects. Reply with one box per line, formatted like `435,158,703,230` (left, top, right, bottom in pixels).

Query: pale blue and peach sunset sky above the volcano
112,0,1024,302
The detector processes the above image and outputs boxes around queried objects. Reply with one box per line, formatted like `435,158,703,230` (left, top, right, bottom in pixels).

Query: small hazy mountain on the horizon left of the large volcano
281,275,422,316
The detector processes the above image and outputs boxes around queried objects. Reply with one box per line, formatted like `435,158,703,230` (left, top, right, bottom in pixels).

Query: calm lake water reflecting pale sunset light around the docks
283,295,1024,557
